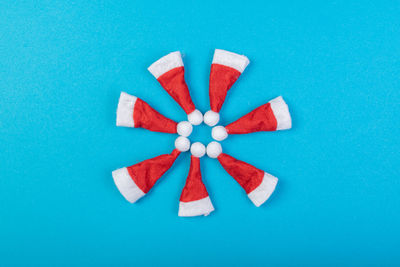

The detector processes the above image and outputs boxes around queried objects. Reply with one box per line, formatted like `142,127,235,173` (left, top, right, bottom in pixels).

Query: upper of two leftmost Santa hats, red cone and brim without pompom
117,92,178,133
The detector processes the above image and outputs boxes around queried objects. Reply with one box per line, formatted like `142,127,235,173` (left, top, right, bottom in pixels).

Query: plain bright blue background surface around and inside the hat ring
0,0,400,266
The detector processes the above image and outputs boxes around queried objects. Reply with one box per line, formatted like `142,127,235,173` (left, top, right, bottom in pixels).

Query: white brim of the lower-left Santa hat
112,168,145,203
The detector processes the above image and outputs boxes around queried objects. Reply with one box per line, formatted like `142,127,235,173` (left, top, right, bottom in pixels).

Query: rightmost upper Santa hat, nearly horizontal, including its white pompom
211,96,292,141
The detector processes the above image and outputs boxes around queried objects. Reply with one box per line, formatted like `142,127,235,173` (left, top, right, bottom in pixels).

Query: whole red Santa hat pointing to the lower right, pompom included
207,142,278,207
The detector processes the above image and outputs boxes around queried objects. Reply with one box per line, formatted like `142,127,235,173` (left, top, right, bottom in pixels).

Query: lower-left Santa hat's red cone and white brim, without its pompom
112,149,180,203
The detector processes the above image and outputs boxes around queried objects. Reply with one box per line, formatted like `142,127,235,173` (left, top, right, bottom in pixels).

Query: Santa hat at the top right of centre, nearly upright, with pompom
204,49,250,126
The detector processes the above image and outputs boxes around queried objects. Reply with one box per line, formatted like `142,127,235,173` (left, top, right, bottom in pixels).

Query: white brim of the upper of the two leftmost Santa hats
117,92,137,127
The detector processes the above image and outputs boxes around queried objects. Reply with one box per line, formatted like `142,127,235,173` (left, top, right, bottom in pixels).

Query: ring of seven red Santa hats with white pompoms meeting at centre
112,49,292,217
